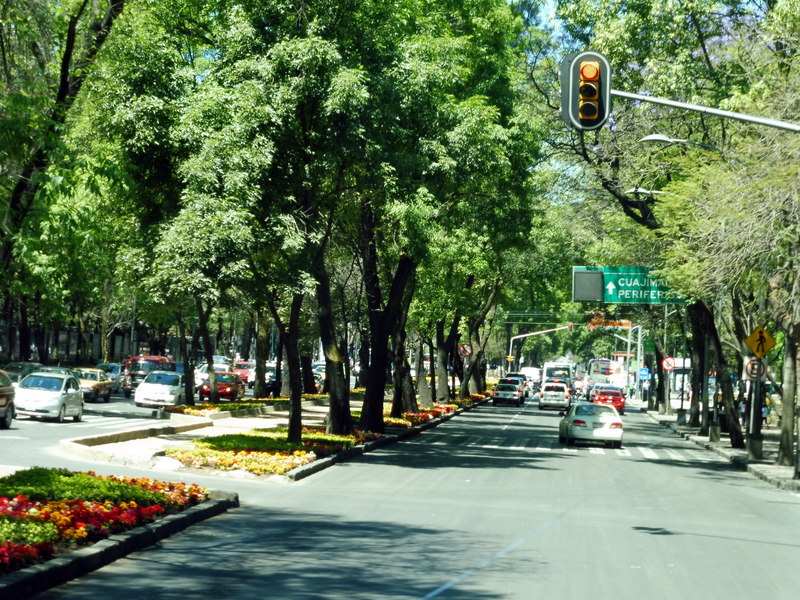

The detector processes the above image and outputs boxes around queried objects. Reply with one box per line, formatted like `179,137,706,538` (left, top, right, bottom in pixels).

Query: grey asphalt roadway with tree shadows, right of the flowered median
6,404,800,600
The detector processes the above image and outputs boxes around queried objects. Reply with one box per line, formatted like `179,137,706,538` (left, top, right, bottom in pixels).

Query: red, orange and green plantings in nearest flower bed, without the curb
0,467,208,575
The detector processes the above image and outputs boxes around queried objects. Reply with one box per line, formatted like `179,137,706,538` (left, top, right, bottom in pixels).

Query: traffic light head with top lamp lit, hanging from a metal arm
561,51,611,131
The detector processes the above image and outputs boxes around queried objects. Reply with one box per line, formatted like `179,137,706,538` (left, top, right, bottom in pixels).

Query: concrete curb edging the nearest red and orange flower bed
0,491,239,600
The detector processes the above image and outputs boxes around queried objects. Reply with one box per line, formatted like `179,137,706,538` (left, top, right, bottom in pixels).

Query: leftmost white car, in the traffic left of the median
14,371,83,423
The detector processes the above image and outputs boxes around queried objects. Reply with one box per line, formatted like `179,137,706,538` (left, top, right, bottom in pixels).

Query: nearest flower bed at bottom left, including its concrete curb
0,467,238,600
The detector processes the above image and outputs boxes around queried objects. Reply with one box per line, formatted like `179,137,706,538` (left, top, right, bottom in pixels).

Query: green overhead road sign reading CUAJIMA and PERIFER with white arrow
572,267,686,304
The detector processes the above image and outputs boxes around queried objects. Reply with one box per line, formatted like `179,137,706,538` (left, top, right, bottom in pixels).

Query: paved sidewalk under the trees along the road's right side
642,408,800,492
